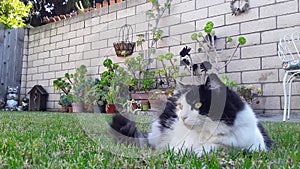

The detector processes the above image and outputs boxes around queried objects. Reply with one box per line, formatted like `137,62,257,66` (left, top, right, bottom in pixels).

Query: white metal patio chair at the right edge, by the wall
278,32,300,121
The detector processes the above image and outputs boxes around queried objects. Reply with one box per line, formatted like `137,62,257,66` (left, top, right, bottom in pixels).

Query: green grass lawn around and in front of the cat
0,112,300,168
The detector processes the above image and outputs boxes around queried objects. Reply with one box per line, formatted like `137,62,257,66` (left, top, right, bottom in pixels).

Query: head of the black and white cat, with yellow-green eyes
177,73,226,129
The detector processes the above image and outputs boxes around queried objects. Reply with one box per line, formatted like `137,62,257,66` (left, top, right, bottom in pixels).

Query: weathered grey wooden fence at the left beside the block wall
0,26,24,98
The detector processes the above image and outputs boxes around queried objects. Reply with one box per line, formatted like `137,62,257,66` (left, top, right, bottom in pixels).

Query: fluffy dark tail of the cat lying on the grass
110,114,149,146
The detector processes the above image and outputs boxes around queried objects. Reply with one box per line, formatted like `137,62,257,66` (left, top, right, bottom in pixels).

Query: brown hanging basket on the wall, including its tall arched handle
113,24,135,57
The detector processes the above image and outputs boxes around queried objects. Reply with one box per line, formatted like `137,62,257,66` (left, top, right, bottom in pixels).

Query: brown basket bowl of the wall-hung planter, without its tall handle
114,42,135,57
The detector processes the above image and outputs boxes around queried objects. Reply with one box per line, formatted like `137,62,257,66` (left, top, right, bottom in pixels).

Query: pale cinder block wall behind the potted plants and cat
21,0,300,113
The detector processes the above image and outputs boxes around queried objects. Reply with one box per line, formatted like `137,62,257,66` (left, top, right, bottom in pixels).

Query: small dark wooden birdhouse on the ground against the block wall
28,85,48,111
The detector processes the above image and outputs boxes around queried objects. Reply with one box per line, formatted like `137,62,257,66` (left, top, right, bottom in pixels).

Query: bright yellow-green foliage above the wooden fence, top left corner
0,0,32,29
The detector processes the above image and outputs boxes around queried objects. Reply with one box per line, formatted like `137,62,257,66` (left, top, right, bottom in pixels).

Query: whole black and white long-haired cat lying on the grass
111,74,273,156
